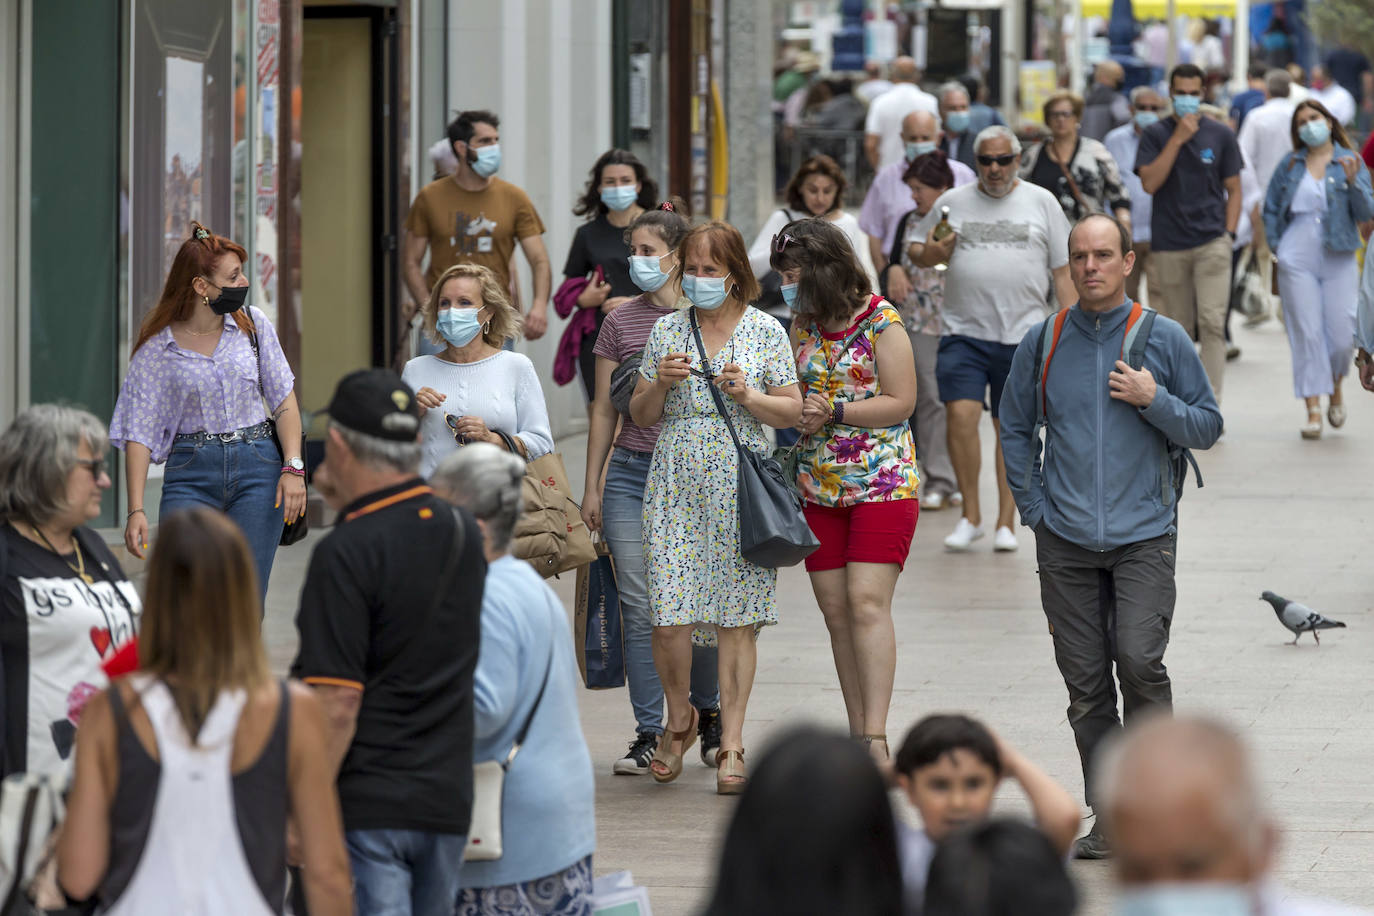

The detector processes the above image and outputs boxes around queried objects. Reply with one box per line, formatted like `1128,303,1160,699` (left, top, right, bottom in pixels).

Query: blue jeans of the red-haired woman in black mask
158,437,283,597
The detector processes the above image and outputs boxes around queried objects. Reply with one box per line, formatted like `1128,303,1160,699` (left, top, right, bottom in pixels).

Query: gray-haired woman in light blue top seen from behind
430,442,596,916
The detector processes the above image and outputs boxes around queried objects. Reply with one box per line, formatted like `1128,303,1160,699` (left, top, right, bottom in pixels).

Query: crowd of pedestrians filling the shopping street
0,59,1374,916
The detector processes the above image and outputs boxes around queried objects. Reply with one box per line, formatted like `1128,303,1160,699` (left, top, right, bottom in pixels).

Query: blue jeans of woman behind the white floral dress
602,448,720,735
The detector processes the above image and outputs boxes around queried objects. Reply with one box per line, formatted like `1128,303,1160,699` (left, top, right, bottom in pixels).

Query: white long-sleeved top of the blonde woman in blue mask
401,350,554,478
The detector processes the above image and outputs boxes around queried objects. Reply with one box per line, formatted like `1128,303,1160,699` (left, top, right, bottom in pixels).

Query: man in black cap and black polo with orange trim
291,369,486,913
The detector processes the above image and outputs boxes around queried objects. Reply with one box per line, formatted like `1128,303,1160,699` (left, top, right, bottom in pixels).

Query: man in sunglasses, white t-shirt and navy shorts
914,125,1079,551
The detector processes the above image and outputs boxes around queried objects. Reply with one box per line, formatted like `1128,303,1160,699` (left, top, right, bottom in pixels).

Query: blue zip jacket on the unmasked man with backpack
999,301,1221,551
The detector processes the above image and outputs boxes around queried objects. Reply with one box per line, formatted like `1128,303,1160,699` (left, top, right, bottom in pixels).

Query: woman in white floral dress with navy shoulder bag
629,222,802,795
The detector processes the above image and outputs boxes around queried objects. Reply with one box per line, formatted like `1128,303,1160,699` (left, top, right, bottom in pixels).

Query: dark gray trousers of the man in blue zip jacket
1035,523,1178,805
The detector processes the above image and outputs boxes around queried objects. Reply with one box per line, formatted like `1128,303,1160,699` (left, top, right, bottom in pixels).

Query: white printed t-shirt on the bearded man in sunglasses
916,181,1069,345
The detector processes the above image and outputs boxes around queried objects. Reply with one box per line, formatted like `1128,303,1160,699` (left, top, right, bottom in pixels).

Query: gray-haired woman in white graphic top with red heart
0,404,143,776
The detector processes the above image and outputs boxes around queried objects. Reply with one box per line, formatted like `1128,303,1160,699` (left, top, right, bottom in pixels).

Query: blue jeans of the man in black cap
344,829,467,916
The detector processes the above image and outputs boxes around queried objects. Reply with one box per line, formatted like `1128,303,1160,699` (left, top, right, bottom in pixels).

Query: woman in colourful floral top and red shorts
772,220,919,759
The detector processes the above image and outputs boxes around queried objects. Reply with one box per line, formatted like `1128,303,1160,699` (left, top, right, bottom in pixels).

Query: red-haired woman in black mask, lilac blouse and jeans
110,222,305,596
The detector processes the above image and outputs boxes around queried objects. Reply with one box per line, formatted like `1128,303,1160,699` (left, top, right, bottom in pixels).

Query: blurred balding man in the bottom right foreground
1098,715,1367,916
